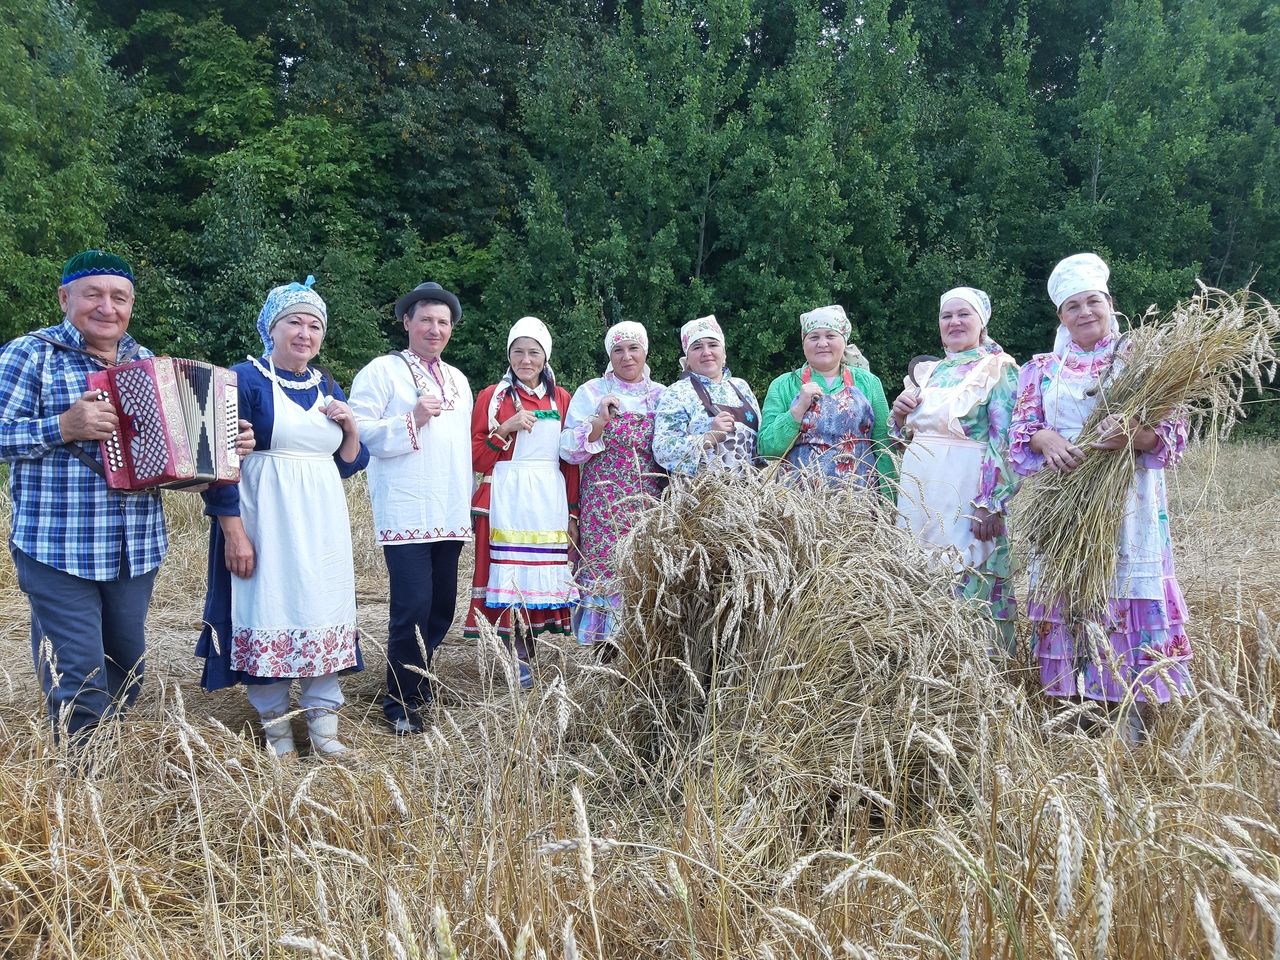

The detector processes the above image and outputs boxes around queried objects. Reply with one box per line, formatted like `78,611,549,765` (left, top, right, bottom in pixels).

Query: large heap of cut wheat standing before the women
601,476,1039,855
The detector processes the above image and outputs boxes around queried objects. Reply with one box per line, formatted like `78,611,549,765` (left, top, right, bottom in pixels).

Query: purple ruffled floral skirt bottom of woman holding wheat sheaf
1027,577,1192,703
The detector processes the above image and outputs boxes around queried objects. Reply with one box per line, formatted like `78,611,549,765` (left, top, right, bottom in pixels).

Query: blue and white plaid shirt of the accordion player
0,320,169,580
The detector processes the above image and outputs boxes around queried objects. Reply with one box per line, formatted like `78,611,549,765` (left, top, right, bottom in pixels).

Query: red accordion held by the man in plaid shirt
88,357,239,490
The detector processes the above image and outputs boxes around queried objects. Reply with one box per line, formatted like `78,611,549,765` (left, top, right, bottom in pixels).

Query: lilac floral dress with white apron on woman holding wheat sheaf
1009,337,1192,703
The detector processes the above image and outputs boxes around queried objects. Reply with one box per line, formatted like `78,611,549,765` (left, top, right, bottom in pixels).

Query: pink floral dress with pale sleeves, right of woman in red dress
561,370,667,644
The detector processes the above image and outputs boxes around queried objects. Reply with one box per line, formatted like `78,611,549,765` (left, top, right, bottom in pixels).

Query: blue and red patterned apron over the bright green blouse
787,367,876,486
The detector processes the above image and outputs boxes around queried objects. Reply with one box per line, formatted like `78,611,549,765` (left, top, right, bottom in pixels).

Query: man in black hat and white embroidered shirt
351,283,472,733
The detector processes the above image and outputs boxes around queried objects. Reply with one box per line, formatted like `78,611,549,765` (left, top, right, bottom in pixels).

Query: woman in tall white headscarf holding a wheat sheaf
1010,253,1190,739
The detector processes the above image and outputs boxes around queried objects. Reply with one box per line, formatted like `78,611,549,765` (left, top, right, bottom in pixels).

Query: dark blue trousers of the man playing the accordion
13,548,156,740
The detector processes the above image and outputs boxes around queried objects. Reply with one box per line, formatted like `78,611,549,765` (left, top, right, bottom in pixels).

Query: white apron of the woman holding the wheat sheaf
1030,361,1165,600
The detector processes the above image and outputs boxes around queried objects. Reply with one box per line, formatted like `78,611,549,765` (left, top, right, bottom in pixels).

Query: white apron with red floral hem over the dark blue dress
232,383,357,677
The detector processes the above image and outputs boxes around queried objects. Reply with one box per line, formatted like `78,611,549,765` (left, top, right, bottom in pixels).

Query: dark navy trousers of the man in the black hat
383,540,462,723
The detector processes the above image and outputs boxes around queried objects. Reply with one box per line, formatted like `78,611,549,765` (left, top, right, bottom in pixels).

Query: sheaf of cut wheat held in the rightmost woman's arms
1018,287,1280,620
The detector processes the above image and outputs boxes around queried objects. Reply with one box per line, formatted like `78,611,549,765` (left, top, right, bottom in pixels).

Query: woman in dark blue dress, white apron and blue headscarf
196,276,369,756
